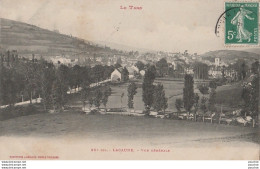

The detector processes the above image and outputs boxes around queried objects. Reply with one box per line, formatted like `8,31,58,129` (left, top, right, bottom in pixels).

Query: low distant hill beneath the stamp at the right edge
201,50,260,63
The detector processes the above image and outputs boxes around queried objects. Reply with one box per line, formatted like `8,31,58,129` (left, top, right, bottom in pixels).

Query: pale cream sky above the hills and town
0,0,240,53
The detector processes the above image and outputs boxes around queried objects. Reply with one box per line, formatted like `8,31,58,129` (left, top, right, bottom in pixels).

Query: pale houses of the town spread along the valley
2,47,240,80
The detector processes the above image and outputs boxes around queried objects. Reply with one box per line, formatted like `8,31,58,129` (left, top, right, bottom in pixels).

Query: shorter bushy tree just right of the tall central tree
153,84,168,113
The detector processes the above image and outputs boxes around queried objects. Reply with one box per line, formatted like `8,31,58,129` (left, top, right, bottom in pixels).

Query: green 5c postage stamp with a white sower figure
225,2,259,45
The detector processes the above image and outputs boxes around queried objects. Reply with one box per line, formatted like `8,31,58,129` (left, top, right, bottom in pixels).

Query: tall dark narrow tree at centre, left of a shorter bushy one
142,66,155,112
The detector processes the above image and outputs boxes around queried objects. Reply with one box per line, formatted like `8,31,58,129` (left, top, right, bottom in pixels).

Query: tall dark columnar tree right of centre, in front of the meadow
183,74,194,113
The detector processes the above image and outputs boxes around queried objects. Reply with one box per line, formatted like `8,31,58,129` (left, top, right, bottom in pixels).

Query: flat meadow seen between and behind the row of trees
69,79,246,112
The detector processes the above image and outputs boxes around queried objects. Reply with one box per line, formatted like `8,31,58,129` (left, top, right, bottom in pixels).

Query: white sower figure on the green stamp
231,5,254,42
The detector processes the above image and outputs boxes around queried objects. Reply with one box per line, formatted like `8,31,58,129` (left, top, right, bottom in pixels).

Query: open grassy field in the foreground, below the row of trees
0,112,257,145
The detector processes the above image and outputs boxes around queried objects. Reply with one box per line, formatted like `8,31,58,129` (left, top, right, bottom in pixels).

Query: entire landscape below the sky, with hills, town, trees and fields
0,19,260,158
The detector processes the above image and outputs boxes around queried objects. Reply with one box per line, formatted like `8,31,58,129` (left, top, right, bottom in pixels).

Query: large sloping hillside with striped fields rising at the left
0,18,115,56
